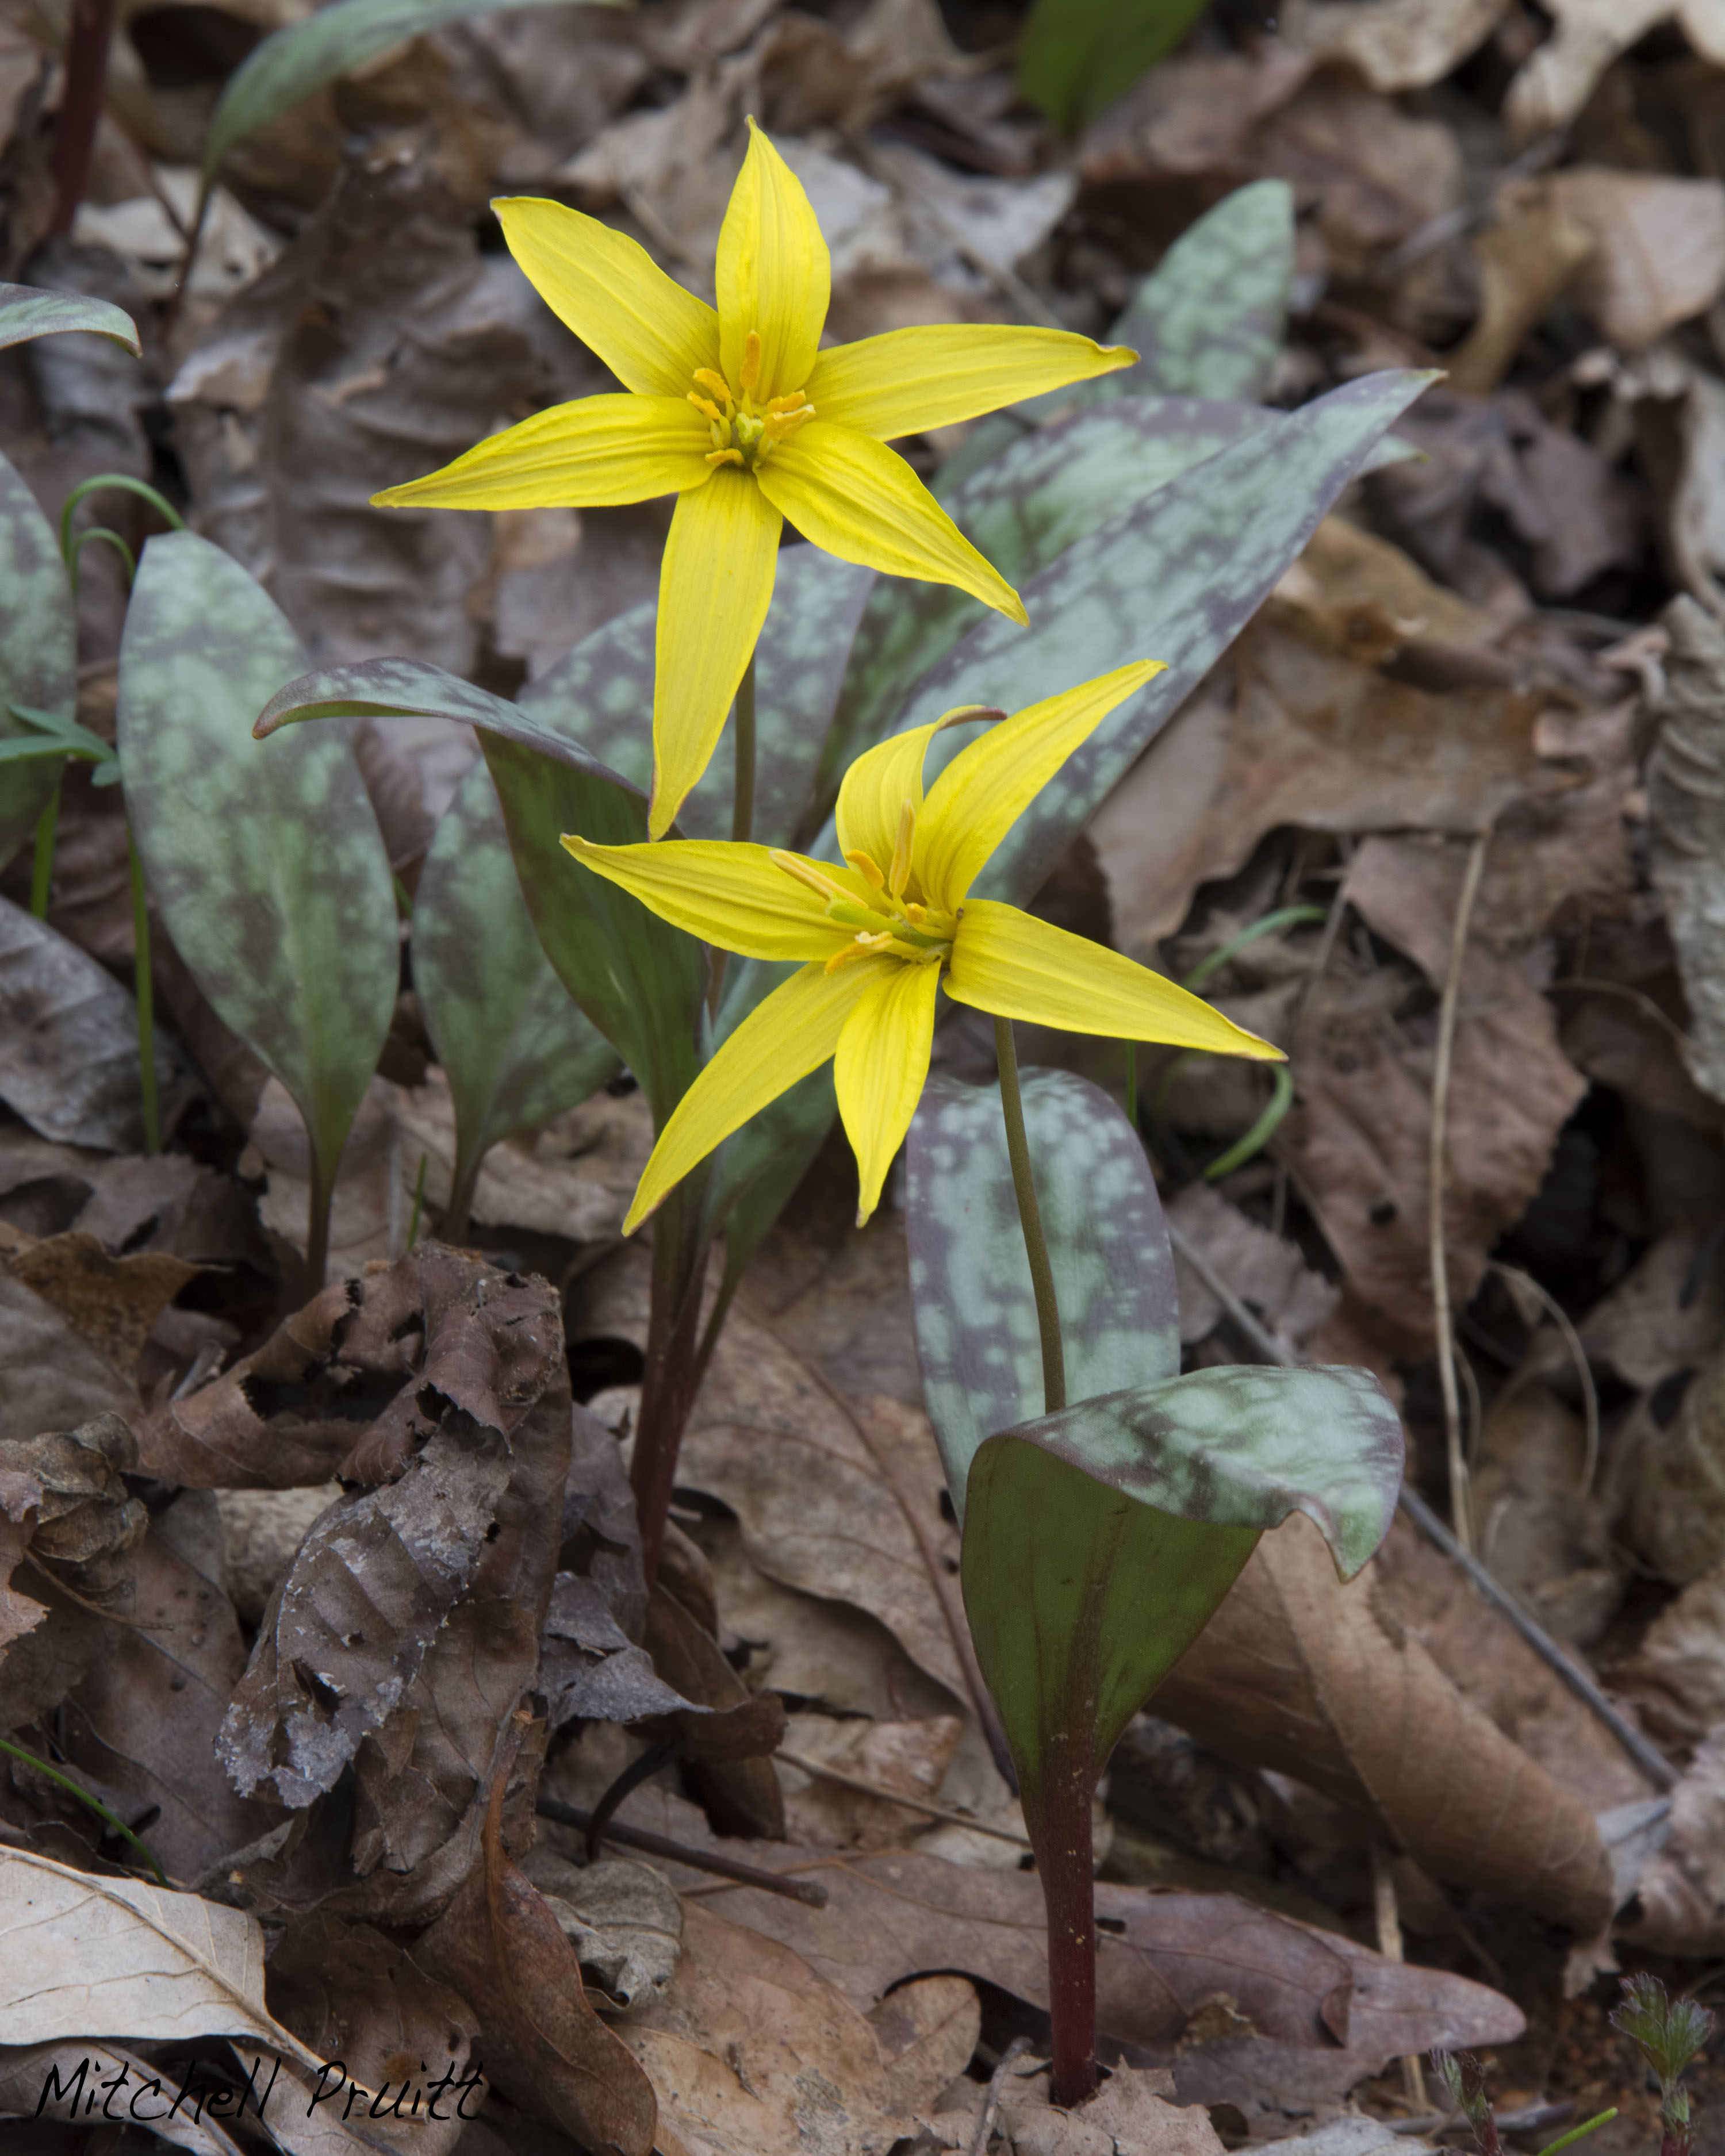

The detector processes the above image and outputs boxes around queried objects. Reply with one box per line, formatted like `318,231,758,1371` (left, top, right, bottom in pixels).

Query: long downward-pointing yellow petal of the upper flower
647,463,781,839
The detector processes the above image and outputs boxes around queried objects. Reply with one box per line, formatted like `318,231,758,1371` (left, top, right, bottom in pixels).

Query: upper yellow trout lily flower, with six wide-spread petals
373,121,1138,839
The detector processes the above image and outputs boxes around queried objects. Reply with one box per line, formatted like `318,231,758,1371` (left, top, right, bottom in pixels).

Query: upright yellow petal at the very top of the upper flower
714,121,833,403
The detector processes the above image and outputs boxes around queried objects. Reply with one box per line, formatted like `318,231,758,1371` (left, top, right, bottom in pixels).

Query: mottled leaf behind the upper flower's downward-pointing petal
522,546,876,845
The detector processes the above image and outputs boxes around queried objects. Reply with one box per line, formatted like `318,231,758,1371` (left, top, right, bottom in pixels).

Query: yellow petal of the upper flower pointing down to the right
757,419,1029,621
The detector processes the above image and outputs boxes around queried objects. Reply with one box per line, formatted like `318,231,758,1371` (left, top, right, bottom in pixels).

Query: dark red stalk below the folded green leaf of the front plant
1024,1733,1098,2111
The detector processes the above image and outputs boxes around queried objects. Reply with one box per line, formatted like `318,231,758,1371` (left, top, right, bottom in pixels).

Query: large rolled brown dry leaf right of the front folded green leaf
1153,1520,1611,1936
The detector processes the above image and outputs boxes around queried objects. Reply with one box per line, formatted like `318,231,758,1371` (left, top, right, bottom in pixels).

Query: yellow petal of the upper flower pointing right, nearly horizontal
807,324,1138,442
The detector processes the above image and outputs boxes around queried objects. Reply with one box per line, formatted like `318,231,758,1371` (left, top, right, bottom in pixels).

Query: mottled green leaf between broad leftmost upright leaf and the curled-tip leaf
414,764,617,1192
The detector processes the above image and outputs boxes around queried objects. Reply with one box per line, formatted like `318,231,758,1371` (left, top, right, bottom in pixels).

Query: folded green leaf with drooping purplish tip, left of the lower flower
256,660,705,1123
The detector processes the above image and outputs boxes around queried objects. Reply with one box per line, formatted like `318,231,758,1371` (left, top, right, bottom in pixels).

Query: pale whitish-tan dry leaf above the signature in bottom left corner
0,1848,321,2072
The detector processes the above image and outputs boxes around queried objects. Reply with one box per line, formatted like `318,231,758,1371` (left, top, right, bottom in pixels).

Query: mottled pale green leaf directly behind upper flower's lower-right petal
822,397,1279,808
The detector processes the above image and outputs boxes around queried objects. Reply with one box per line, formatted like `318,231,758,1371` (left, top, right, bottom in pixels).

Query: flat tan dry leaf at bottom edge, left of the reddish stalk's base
619,1902,981,2156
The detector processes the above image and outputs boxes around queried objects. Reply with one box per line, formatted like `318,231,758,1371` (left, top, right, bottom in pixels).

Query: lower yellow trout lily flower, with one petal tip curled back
563,664,1281,1233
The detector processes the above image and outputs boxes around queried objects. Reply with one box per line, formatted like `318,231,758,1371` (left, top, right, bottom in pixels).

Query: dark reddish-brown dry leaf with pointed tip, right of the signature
414,1774,656,2156
